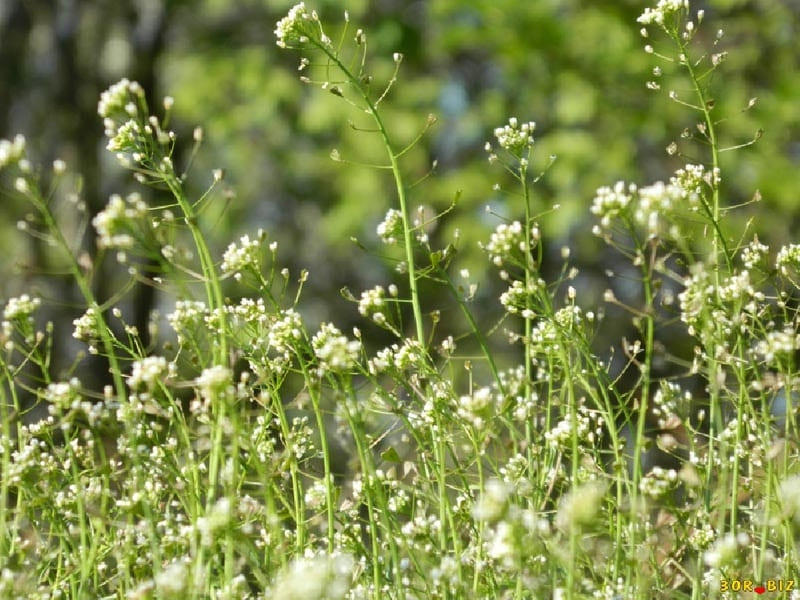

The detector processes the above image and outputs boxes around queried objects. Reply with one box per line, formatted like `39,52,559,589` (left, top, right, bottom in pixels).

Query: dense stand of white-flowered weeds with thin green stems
0,0,800,600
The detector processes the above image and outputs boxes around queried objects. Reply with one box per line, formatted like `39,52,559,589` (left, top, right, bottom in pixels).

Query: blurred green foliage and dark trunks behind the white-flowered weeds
0,0,800,384
